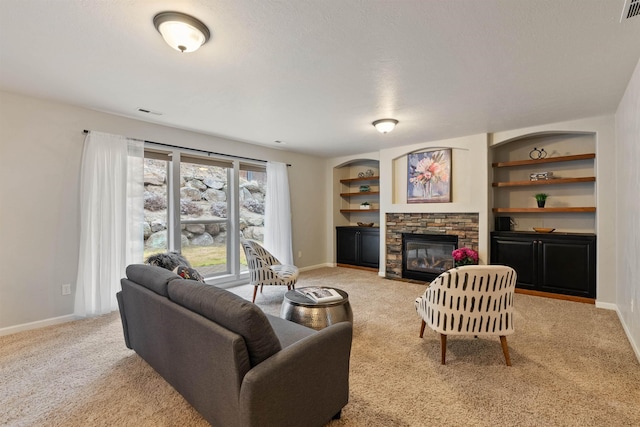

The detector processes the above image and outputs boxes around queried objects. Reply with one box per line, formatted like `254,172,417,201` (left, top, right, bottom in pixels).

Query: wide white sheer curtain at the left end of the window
74,131,144,317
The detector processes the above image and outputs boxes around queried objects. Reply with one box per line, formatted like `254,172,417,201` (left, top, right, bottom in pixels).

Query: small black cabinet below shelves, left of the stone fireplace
336,227,380,269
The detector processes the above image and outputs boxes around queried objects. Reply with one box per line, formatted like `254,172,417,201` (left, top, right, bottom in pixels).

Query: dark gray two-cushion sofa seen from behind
117,264,352,427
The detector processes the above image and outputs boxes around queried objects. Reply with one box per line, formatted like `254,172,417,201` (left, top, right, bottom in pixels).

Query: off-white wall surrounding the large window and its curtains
0,92,328,333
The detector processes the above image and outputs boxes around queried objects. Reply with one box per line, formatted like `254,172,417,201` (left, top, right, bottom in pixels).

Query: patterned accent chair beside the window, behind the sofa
240,239,299,303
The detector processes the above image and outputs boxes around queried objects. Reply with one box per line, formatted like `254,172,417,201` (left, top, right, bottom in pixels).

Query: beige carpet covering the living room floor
0,268,640,427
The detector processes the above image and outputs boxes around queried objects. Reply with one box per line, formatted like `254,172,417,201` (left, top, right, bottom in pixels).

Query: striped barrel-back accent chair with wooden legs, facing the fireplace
415,265,516,366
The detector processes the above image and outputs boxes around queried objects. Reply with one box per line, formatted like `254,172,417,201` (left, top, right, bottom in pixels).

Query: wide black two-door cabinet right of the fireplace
491,231,596,298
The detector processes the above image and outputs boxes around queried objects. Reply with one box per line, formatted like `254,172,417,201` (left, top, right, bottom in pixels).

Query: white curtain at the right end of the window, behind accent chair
264,162,293,265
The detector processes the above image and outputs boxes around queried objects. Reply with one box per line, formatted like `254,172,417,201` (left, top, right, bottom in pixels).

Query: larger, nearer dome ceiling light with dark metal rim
153,12,210,52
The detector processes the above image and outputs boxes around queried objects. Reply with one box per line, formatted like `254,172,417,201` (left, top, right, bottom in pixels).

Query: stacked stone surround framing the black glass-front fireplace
385,212,479,279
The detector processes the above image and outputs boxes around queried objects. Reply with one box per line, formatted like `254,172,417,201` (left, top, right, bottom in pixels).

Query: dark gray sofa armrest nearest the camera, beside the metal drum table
240,322,352,427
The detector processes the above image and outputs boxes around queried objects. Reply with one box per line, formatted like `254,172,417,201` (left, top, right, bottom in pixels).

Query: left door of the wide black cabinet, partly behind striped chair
491,236,537,289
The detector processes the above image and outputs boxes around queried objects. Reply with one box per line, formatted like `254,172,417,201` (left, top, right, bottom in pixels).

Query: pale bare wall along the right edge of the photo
612,57,640,360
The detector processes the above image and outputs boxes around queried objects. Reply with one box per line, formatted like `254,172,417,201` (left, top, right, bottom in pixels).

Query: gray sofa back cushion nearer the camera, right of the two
168,279,282,366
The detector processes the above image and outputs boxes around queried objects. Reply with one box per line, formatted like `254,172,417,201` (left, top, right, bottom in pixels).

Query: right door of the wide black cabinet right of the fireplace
539,238,596,298
